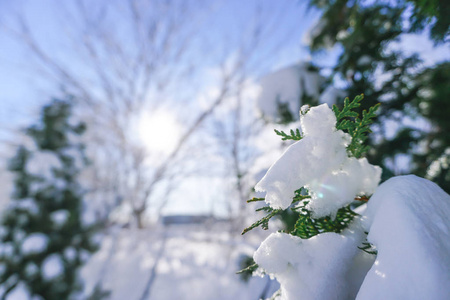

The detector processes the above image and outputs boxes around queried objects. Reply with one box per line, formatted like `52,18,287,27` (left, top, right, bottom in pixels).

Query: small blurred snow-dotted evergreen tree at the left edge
0,100,96,300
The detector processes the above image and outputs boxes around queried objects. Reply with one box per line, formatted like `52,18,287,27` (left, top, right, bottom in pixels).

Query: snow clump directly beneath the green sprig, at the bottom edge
254,220,373,299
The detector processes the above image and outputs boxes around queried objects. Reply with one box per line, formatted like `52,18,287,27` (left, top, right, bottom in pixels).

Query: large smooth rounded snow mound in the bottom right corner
357,175,450,300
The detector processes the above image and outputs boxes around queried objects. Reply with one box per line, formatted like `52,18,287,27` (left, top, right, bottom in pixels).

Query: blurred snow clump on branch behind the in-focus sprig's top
258,62,324,119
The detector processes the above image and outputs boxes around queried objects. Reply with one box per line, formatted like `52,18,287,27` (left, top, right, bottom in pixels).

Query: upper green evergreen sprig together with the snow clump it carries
243,95,381,238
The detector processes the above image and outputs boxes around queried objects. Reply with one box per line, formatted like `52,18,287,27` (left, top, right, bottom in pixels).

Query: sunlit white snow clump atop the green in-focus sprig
255,104,381,217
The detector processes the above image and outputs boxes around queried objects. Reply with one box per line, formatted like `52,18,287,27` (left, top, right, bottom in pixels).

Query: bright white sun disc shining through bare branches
138,111,181,154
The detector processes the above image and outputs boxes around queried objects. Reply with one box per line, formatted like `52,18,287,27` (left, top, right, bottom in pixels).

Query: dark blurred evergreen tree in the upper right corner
310,0,450,192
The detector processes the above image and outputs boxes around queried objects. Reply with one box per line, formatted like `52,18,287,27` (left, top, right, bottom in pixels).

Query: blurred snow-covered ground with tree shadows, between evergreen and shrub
82,224,278,300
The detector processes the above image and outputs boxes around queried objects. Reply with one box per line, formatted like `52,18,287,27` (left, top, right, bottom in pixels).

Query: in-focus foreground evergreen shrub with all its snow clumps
243,96,450,300
